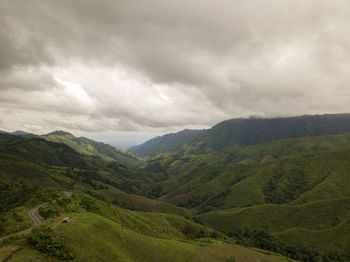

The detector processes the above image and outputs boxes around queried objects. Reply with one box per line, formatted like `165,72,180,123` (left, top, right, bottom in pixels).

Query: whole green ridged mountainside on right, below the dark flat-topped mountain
138,133,350,261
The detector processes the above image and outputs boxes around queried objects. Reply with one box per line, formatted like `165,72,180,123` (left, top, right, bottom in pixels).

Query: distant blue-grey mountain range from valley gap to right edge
133,114,350,157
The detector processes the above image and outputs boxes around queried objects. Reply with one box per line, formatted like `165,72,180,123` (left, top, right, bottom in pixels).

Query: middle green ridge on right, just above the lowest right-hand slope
146,150,350,211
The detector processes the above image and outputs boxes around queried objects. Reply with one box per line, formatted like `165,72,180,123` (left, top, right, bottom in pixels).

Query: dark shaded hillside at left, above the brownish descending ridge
0,135,158,192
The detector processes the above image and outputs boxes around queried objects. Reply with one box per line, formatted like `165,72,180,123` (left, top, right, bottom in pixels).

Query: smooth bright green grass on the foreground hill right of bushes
50,213,287,261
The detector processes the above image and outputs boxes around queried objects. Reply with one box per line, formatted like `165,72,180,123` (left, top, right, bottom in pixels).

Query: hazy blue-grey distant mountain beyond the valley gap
128,129,205,157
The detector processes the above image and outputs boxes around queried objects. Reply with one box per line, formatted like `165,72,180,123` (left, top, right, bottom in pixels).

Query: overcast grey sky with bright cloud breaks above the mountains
0,0,350,148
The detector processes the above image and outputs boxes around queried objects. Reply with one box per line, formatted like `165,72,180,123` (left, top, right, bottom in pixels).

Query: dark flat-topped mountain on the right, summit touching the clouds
192,114,350,152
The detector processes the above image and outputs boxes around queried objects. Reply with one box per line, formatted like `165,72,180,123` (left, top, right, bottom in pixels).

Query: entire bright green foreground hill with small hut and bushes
0,189,291,262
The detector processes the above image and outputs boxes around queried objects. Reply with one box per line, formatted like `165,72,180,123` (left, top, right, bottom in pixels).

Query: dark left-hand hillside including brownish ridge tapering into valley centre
0,135,190,216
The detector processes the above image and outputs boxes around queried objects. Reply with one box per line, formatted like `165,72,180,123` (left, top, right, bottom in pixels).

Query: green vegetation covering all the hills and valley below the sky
0,115,350,262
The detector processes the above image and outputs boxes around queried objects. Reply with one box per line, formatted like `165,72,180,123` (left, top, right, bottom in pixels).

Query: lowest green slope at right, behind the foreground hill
198,198,350,256
